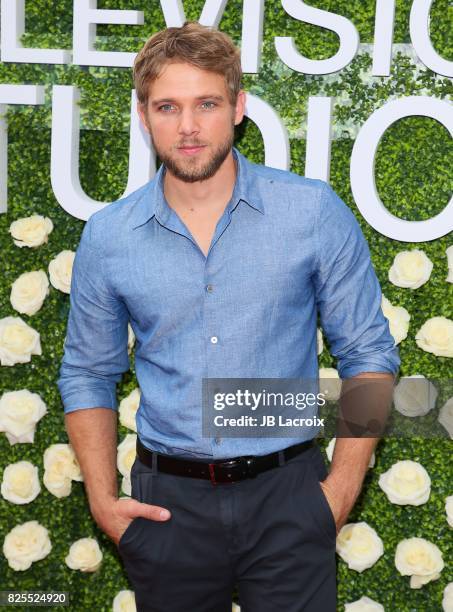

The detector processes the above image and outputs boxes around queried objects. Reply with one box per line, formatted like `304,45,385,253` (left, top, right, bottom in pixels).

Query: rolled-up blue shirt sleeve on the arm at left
57,217,130,413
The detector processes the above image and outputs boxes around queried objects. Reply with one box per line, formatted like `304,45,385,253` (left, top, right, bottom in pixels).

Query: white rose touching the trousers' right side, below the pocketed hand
336,521,384,572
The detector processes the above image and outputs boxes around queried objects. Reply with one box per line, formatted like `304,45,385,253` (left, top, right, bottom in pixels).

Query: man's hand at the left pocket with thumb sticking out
92,498,171,546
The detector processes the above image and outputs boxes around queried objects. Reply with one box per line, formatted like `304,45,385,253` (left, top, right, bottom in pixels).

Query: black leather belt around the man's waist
137,437,314,484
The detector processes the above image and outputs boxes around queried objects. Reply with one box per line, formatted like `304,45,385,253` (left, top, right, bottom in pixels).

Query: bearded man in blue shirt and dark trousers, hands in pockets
58,23,399,612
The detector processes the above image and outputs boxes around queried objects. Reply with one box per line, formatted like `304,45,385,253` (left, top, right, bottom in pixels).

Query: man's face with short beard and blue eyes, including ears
138,63,245,183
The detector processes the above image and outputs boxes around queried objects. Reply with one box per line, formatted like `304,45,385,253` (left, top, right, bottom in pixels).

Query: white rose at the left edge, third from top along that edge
0,317,42,366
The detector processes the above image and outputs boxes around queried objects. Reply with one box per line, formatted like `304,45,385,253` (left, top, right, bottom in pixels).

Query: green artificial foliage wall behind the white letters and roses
0,0,453,612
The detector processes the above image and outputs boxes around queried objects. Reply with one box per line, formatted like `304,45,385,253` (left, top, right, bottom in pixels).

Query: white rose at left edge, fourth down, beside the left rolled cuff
0,389,47,444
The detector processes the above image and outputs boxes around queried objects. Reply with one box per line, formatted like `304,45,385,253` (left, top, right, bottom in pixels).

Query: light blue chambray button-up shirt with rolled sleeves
57,148,400,459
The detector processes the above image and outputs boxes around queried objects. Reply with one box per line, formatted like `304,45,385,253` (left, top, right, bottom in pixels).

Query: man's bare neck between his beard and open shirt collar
164,151,236,210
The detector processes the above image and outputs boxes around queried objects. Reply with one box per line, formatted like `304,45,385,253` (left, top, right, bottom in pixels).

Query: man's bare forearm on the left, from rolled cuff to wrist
65,408,118,514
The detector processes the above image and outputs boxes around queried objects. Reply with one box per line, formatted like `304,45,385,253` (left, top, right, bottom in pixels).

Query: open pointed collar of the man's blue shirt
132,147,264,229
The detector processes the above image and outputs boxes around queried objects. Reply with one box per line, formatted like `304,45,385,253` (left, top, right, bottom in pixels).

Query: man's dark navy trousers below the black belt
118,444,336,612
